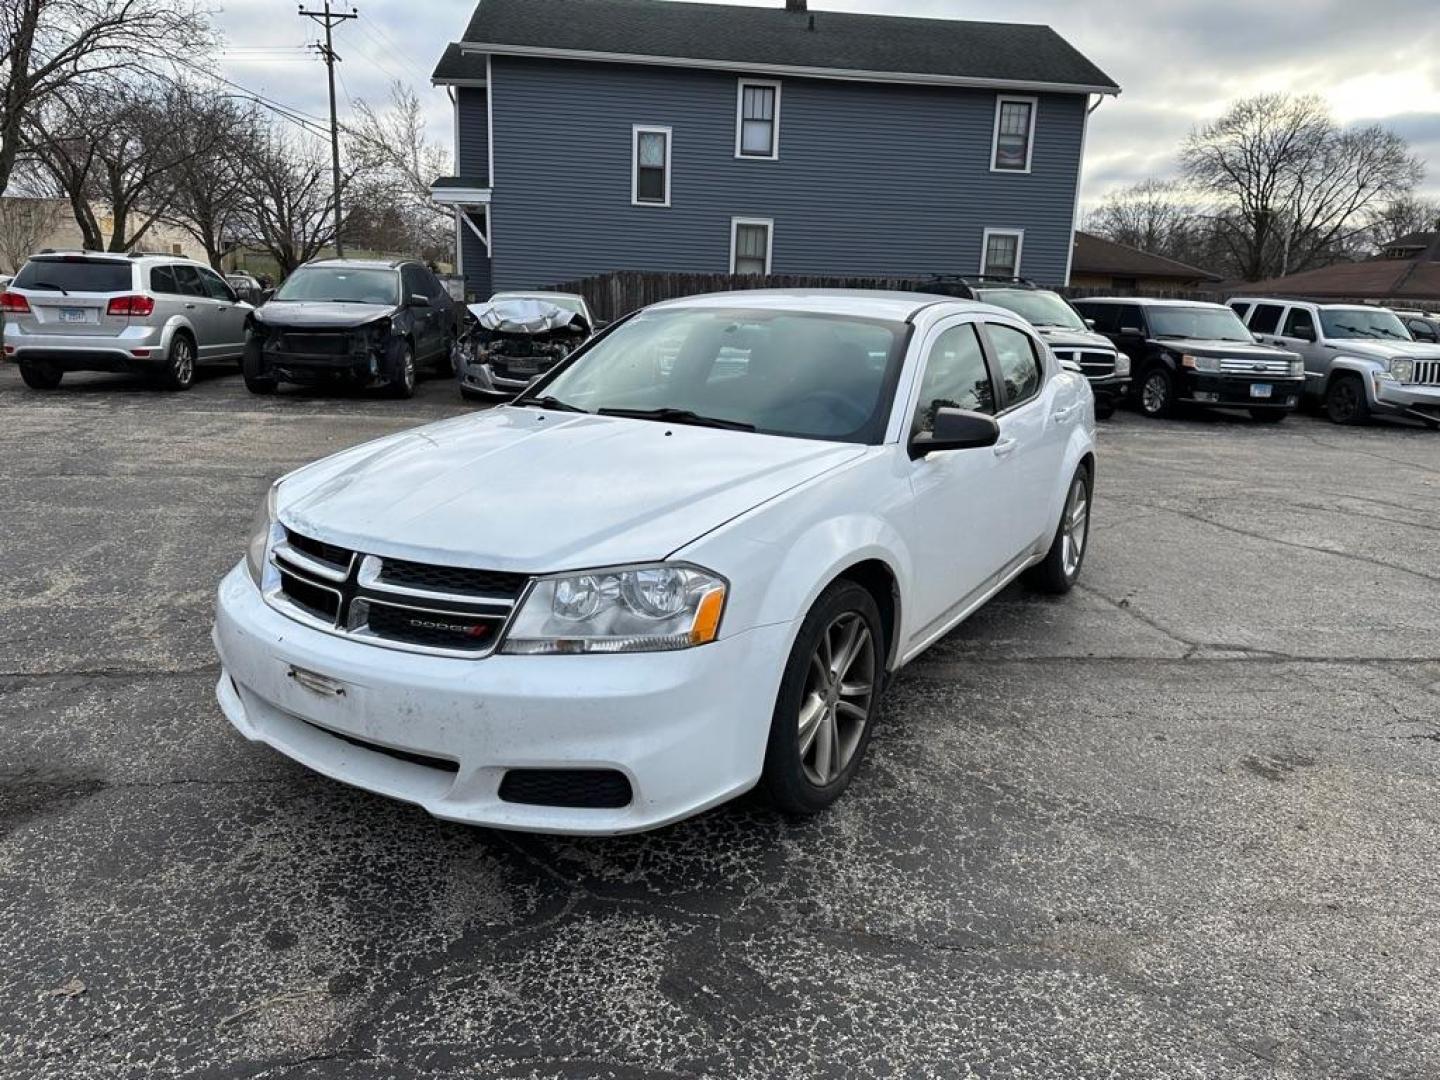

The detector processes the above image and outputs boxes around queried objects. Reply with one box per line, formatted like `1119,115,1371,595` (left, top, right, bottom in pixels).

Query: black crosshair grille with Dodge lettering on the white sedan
266,528,530,658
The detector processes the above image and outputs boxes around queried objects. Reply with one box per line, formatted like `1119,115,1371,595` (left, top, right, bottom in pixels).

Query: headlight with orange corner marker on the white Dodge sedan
500,563,726,655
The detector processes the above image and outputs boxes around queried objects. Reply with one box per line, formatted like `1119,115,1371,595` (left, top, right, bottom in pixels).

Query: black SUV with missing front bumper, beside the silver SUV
242,259,459,397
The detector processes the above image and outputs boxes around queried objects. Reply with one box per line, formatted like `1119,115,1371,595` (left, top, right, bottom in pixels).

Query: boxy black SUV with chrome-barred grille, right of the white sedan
1074,297,1305,423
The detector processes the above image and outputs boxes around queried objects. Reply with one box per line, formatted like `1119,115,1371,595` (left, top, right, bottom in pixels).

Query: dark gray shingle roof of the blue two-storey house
435,0,1119,94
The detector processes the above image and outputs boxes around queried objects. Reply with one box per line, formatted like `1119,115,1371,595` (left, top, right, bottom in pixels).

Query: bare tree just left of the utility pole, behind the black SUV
243,127,354,276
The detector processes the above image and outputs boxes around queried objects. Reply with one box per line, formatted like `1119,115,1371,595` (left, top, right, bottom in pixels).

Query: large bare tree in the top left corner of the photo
0,0,212,192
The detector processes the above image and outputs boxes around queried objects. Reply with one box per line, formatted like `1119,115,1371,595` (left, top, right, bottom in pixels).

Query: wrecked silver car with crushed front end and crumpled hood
452,294,592,400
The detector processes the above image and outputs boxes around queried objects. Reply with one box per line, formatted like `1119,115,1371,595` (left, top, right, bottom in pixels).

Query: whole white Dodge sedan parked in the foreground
215,292,1094,834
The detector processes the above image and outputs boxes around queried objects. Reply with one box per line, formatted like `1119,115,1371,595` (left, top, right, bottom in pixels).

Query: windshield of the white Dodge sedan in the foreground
521,308,906,442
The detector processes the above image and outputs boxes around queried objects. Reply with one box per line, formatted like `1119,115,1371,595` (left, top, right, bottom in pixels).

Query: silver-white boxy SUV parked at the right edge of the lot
1230,297,1440,428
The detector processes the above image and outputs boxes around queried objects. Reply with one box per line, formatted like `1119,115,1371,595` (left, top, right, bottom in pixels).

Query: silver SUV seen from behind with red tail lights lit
0,252,253,390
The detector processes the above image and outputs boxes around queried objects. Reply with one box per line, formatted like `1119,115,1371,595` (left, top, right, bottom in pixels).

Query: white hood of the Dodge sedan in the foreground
279,408,868,573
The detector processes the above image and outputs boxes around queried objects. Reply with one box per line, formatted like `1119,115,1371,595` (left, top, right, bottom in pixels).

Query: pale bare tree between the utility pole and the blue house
346,82,455,258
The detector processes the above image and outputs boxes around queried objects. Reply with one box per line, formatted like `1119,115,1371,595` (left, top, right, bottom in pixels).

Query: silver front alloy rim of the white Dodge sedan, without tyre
796,611,877,788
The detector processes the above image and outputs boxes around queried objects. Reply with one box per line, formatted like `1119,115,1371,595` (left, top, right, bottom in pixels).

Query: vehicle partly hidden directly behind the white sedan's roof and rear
924,275,1130,420
